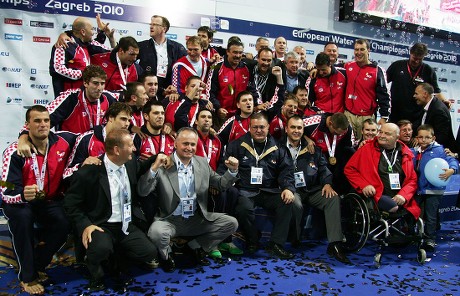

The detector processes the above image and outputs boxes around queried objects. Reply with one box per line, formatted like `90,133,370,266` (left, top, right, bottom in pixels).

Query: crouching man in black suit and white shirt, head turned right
64,129,157,291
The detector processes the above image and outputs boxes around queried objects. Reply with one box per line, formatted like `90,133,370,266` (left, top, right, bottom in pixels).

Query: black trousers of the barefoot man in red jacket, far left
3,201,70,283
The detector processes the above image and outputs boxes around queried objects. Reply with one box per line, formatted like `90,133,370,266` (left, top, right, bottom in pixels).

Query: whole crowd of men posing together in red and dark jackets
2,15,457,294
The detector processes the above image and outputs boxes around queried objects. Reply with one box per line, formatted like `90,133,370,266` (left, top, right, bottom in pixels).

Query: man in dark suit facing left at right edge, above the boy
414,82,458,152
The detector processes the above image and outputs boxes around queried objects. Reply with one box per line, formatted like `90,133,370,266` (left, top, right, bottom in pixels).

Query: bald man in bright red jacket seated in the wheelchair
344,123,420,219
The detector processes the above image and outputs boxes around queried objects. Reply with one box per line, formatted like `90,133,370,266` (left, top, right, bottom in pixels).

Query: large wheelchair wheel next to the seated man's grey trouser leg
341,193,370,252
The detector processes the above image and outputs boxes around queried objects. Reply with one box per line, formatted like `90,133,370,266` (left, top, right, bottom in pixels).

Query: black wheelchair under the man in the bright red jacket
341,193,426,268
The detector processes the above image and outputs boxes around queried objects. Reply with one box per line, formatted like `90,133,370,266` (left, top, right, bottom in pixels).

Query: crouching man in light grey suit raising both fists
139,127,238,272
